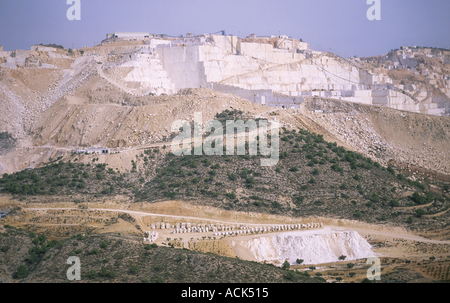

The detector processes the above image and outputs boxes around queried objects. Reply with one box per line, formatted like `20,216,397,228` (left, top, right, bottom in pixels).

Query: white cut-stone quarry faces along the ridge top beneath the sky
0,35,450,115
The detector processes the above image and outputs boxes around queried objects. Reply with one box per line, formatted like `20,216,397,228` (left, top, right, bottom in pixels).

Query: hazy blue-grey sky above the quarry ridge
0,0,450,57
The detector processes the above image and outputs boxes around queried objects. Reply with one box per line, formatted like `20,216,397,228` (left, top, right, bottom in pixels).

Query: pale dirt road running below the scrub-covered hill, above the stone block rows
27,207,450,244
